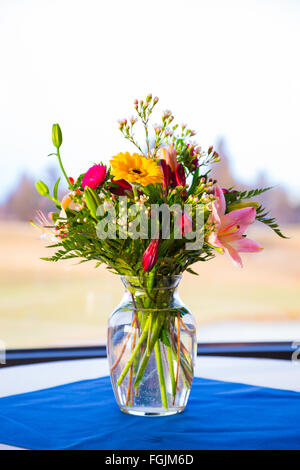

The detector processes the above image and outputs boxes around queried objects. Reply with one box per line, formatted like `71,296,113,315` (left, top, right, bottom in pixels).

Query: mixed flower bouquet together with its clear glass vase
32,95,284,415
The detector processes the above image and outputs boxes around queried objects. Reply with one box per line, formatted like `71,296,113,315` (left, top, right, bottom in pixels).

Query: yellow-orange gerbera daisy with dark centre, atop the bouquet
110,152,163,186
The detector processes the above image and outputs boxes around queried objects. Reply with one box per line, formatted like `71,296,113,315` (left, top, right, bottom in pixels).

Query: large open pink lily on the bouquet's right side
207,185,263,267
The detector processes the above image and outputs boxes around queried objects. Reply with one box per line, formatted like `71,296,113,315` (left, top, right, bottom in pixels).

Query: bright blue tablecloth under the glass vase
0,377,300,450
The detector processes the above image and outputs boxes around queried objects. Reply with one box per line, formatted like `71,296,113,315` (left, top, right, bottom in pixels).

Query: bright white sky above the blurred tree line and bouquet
0,0,300,200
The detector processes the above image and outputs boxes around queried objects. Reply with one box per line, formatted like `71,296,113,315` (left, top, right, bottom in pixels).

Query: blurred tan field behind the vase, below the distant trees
0,223,300,348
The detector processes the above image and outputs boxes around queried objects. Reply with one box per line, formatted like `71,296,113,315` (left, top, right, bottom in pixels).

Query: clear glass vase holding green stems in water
107,275,197,416
